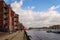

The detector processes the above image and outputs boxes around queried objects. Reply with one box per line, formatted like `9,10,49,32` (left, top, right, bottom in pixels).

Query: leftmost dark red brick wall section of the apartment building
0,0,5,31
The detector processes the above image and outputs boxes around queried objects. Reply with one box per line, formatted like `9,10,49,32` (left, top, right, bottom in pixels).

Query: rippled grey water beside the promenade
27,30,60,40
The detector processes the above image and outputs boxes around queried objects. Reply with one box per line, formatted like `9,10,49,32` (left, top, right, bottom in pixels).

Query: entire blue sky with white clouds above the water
5,0,60,28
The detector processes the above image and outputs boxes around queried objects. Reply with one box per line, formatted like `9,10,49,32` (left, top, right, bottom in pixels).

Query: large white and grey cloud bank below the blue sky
11,0,60,27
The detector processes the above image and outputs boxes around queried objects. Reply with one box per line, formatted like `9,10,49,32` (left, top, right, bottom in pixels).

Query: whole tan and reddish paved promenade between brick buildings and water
0,31,27,40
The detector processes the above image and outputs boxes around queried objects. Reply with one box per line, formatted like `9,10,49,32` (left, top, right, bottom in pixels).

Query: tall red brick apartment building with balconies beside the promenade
0,0,19,32
